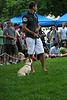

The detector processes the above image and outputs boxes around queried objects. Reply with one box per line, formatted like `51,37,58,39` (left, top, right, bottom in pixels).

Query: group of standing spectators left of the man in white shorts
0,19,27,66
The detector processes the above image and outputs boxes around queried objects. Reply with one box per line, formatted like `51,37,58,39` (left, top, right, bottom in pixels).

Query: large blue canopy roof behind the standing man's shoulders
10,12,55,26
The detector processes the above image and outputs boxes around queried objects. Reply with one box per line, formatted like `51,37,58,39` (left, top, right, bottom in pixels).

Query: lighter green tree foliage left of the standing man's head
0,0,30,21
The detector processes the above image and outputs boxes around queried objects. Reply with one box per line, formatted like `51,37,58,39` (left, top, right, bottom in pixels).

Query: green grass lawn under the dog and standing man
0,57,67,100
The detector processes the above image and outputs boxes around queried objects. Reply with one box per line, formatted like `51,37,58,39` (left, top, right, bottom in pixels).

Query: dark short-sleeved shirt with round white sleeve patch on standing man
22,11,38,38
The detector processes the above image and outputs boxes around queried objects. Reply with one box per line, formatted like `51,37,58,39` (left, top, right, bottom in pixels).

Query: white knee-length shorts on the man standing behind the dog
26,37,44,55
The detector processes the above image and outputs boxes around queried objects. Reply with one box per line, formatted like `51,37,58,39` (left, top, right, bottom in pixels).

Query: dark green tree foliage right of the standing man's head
37,0,67,17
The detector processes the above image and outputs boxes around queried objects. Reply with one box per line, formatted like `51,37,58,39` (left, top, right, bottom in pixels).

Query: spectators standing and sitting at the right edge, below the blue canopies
47,23,67,57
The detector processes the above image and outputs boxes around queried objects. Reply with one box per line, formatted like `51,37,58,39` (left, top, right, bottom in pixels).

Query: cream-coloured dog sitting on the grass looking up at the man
17,59,32,76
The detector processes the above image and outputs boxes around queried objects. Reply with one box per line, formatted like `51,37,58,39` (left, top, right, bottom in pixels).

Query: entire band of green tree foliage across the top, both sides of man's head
0,0,67,19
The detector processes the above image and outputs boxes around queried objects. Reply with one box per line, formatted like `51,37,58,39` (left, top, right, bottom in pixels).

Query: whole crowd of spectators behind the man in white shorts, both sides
0,20,67,66
